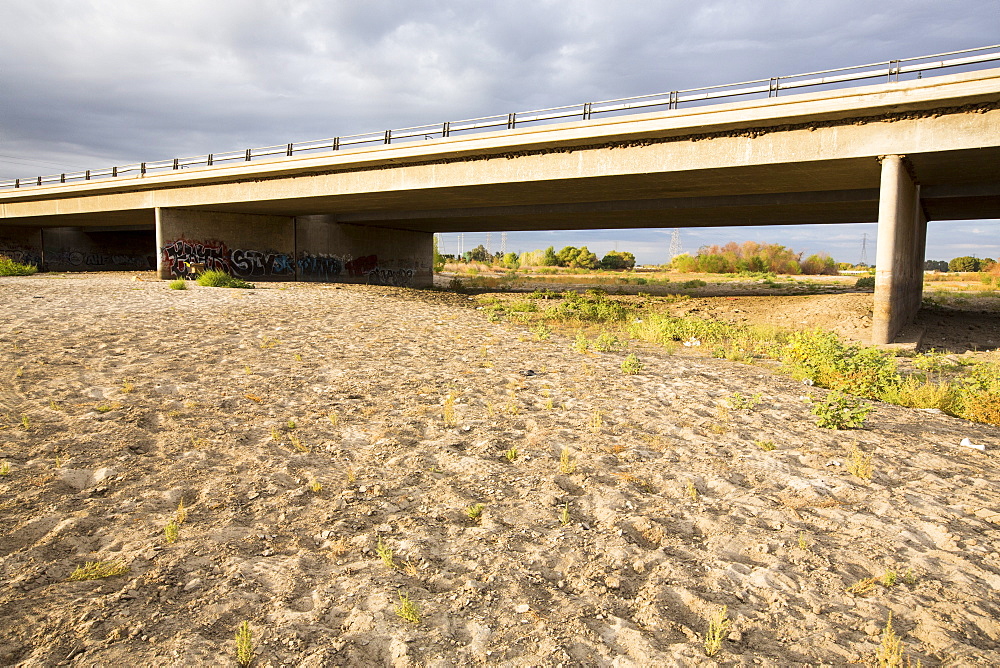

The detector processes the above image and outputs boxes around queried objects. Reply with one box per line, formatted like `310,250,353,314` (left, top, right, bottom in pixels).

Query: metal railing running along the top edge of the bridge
0,44,1000,189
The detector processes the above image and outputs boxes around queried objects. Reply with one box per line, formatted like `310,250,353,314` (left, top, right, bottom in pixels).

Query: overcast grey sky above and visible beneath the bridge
0,0,1000,262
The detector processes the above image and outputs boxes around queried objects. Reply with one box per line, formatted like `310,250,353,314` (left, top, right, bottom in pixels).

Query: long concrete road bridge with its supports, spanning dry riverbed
0,61,1000,343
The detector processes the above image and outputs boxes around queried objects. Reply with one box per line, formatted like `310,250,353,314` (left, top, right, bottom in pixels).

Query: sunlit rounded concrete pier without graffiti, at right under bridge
872,155,927,344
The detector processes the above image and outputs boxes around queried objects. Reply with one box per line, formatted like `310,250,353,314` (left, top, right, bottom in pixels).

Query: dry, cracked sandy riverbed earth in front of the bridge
0,274,1000,666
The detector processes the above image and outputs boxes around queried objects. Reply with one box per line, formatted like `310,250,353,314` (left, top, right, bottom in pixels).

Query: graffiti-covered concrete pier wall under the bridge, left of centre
156,208,433,287
